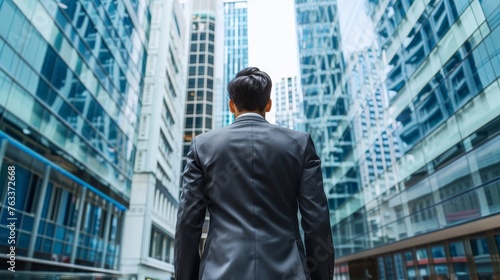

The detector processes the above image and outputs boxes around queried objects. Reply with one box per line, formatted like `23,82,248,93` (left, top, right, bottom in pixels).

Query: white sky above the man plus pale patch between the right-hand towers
248,0,373,123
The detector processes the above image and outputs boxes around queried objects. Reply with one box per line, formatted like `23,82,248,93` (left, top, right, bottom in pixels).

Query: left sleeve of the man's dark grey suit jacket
174,139,208,280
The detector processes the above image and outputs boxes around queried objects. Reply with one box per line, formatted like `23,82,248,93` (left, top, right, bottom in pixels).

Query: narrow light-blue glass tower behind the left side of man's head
220,0,248,127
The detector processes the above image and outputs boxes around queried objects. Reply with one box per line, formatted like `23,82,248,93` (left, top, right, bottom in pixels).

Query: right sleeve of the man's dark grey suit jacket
298,135,335,280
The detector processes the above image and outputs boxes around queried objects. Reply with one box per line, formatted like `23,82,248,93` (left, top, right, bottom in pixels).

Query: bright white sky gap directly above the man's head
248,0,298,123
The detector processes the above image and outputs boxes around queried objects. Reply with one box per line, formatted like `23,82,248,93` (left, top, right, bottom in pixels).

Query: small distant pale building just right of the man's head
273,76,304,130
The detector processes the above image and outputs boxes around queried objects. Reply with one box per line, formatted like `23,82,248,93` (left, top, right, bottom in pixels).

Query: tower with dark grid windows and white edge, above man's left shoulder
182,0,224,167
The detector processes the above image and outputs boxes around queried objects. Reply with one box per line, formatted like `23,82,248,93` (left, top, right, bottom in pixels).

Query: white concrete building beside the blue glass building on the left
121,0,189,279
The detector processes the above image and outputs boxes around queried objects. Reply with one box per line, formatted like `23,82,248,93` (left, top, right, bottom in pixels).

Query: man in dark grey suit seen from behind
175,67,334,280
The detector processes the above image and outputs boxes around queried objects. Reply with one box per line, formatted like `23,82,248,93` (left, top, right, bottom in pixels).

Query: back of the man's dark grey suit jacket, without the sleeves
174,115,333,279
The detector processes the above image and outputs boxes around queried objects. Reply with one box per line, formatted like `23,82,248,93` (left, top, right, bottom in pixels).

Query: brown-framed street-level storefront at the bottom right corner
334,225,500,280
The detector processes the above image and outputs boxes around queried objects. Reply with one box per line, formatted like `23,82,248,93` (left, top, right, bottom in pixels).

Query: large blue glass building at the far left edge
0,0,151,278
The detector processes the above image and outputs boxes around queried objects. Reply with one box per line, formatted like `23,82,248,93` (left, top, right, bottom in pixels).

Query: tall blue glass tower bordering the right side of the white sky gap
295,0,350,230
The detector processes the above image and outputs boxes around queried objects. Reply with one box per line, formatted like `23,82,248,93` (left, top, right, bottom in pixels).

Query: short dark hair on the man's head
227,67,273,111
